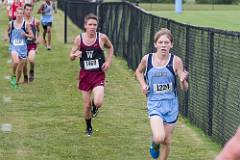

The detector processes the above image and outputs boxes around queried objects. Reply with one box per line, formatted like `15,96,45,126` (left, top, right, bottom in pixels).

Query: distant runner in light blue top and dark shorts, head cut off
38,0,56,50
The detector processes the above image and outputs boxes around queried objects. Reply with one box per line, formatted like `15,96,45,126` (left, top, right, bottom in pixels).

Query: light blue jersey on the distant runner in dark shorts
41,3,53,24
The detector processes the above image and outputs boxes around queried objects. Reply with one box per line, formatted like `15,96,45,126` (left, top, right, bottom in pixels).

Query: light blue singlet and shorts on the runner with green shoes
9,21,28,59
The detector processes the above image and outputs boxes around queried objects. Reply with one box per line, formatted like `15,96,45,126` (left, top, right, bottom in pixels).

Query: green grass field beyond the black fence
140,3,240,31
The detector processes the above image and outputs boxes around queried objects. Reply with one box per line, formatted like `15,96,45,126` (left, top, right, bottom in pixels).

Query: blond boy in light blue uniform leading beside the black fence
136,28,188,160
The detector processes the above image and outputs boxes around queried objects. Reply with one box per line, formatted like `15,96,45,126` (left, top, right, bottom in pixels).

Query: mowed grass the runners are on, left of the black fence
0,3,220,160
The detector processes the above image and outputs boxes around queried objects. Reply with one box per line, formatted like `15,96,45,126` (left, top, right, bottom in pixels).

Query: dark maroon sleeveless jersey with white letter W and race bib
80,32,105,71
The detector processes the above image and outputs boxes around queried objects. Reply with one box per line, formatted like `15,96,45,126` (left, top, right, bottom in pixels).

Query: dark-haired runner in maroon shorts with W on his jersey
70,14,113,136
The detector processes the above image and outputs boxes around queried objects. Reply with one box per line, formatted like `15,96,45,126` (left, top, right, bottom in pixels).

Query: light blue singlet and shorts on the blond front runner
144,53,178,123
